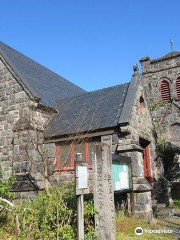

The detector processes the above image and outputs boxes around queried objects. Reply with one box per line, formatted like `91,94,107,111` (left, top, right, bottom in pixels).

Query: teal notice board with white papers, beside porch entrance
112,155,131,191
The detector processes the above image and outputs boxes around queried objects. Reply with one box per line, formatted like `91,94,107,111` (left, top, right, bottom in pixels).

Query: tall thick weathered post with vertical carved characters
93,136,116,240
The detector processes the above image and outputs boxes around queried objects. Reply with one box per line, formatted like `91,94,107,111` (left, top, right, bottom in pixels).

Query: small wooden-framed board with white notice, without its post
75,153,89,195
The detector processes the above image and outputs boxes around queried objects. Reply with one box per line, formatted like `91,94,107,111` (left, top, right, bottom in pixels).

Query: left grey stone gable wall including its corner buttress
0,57,54,195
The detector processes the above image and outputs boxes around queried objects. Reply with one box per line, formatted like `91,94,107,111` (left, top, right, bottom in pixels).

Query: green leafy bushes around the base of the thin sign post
12,184,96,240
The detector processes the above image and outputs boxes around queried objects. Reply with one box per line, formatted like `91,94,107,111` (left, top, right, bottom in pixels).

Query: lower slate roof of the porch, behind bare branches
46,83,129,138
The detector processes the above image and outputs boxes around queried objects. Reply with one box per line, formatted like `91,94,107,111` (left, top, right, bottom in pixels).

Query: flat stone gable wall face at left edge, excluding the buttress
0,58,31,176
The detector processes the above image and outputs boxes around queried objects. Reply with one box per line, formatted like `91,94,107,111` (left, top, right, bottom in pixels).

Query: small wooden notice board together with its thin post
75,153,89,240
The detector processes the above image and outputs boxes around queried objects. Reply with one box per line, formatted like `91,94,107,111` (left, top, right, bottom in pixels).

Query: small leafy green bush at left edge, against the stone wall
0,167,15,199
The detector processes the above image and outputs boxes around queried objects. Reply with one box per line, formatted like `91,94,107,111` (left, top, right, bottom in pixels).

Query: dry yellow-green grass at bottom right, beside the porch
116,212,177,240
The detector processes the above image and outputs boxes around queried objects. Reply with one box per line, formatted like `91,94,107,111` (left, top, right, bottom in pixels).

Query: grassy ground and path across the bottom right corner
116,192,180,240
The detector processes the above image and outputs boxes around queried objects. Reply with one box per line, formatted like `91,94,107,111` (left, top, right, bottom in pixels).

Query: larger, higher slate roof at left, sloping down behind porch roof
0,41,85,107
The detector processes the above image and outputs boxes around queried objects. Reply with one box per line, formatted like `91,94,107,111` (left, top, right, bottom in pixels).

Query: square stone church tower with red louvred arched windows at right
140,51,180,182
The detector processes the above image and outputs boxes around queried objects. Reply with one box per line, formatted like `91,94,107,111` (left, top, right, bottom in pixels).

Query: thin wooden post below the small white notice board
77,195,84,240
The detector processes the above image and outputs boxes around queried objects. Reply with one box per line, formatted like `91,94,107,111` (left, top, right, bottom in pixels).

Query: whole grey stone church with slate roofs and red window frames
0,42,180,219
